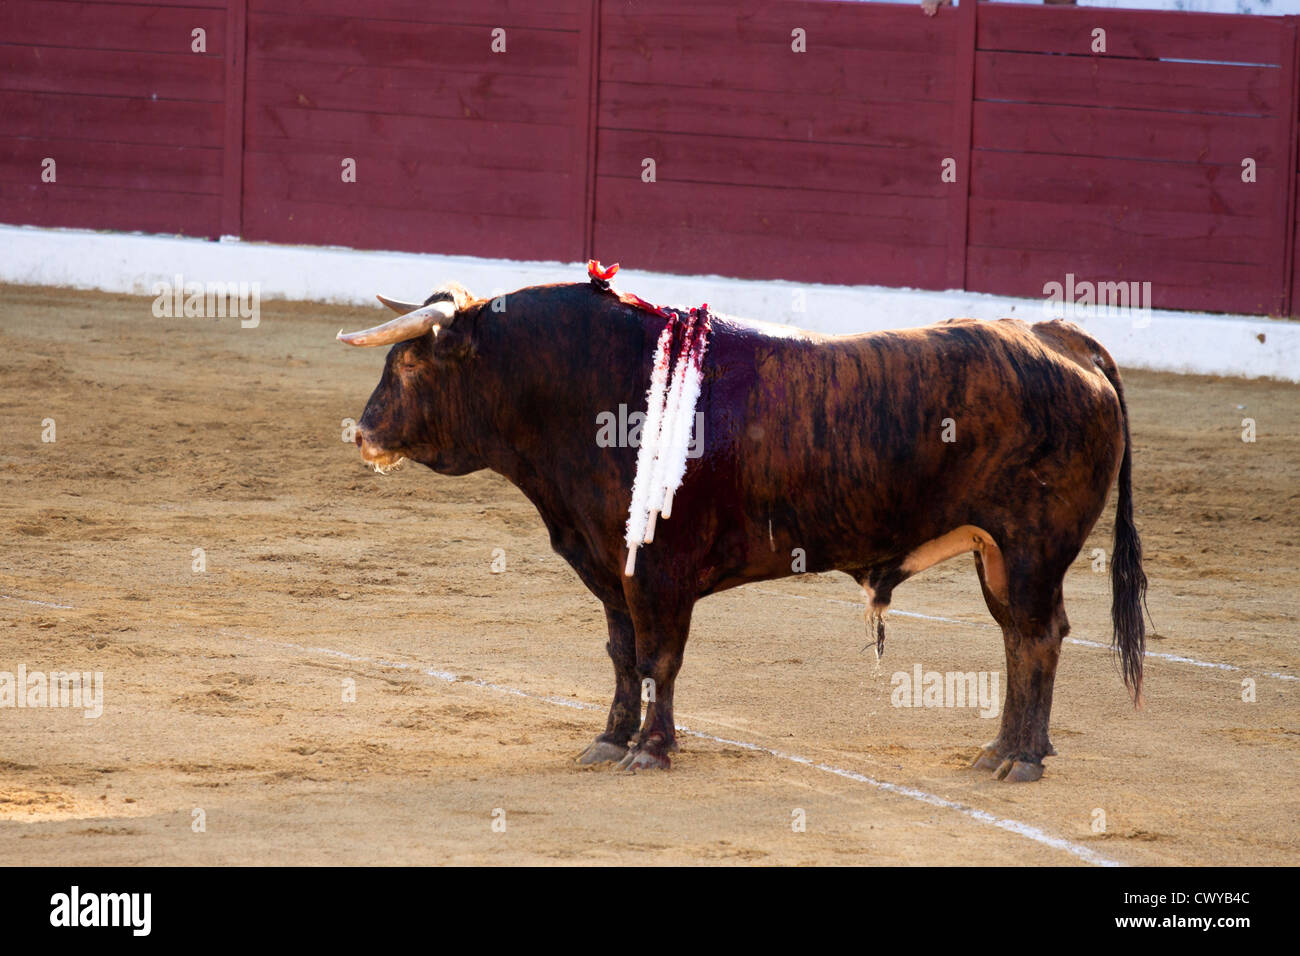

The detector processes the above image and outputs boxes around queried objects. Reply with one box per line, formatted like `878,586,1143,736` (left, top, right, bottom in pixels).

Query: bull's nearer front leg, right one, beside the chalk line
619,583,696,770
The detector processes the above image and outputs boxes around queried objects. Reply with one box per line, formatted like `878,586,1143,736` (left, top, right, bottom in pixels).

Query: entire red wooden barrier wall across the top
0,0,1300,313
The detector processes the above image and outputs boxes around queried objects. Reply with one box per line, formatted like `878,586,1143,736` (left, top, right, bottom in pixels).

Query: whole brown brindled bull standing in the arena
339,274,1147,780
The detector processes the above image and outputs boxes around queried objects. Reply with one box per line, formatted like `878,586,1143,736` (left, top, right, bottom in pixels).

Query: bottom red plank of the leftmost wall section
0,182,221,238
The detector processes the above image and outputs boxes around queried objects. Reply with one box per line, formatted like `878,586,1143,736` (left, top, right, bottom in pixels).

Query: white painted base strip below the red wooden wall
0,225,1300,382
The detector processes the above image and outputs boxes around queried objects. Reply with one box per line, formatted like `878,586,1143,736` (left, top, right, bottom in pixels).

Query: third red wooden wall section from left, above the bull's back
594,0,961,289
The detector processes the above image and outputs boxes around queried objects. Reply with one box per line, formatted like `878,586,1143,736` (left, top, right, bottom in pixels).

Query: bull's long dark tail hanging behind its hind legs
1102,356,1147,706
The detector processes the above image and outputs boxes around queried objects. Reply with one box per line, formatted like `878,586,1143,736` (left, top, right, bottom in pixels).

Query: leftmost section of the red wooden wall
0,0,226,237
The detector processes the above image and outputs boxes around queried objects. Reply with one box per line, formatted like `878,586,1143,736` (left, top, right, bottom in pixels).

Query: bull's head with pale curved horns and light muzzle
338,284,484,475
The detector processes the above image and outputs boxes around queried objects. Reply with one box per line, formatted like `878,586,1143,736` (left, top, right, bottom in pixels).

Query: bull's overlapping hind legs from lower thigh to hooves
974,557,1070,782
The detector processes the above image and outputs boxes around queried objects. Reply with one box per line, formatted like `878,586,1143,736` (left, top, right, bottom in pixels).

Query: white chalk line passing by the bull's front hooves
220,631,1125,866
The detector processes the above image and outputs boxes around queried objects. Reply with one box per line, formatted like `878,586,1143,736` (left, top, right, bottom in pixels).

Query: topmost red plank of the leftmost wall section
0,0,226,57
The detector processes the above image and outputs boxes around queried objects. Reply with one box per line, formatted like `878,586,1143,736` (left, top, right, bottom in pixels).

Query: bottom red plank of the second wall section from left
244,202,567,260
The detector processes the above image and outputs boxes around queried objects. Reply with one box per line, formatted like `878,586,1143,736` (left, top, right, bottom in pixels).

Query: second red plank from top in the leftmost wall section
0,44,225,101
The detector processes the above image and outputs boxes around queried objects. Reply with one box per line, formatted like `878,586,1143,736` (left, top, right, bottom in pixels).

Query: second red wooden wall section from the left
243,0,590,260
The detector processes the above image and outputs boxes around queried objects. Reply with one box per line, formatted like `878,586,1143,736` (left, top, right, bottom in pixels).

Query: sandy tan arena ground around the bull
0,286,1300,865
